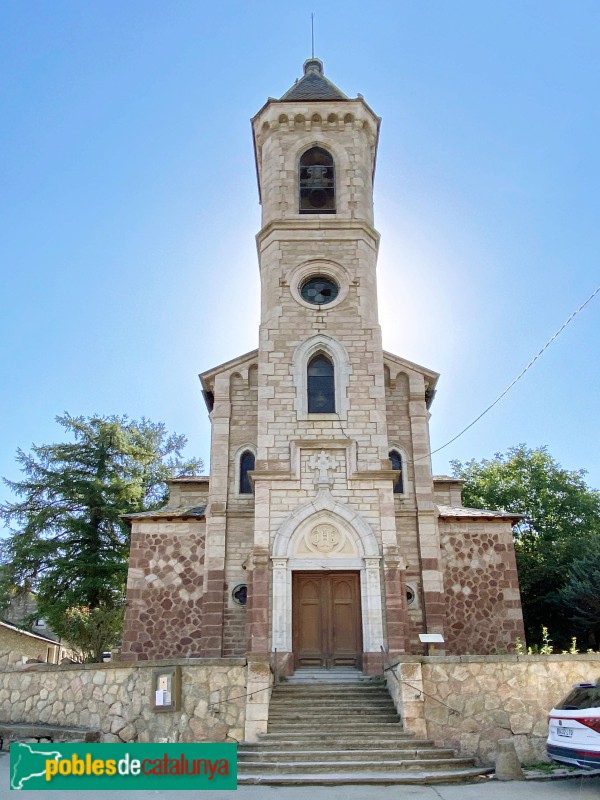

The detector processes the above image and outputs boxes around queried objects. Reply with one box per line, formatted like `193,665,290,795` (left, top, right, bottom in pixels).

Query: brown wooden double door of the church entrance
292,572,362,669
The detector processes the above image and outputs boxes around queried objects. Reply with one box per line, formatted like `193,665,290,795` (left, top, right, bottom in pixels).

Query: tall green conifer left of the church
0,414,201,659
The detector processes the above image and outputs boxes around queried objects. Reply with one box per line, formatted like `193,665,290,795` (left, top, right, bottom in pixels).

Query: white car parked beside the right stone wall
546,681,600,769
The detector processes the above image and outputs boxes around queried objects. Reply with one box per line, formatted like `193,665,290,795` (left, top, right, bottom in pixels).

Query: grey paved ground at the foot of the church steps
0,753,600,800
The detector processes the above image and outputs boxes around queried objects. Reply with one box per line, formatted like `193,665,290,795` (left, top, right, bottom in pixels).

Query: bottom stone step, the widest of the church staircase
238,767,493,786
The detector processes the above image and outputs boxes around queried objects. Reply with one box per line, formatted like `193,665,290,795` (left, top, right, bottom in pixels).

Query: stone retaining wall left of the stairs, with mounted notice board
0,659,252,742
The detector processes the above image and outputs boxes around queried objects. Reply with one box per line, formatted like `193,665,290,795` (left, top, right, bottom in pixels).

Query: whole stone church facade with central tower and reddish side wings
122,59,524,674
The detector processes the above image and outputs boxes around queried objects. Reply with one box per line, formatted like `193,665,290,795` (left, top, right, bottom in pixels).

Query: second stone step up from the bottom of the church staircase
238,758,473,775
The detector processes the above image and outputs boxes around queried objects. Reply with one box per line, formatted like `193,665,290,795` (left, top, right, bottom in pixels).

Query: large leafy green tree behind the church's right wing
452,444,600,647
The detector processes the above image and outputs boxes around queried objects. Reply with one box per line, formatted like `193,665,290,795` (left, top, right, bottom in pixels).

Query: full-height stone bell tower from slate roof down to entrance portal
249,58,420,667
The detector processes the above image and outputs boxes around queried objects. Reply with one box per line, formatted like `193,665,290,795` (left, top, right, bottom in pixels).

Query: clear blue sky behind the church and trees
0,0,600,512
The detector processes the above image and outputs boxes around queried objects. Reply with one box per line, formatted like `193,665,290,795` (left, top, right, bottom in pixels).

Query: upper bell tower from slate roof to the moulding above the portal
252,59,388,470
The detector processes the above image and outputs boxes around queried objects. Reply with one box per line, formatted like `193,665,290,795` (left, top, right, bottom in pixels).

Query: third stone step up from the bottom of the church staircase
238,746,454,762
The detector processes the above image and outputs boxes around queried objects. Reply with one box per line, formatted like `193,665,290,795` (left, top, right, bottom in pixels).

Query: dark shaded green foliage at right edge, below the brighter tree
560,536,600,650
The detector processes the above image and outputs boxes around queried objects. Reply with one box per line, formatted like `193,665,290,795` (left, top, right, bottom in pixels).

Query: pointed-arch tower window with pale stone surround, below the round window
292,334,352,420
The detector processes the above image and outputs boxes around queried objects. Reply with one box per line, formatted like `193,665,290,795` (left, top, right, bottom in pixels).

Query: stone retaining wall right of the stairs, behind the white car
387,653,600,764
